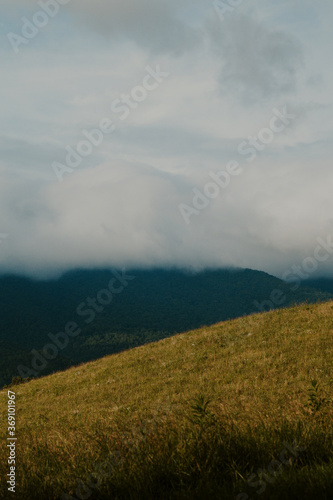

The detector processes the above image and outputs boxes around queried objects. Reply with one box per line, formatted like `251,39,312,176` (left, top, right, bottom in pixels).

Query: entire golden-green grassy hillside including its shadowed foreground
0,302,333,500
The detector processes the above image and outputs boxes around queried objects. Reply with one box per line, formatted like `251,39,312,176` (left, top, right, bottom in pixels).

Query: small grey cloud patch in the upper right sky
208,14,303,104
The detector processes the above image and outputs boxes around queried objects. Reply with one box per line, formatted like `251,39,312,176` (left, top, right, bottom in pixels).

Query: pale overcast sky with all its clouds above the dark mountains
0,0,333,277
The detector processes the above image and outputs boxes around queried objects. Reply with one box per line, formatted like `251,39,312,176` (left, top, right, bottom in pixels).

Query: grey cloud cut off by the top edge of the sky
4,0,202,55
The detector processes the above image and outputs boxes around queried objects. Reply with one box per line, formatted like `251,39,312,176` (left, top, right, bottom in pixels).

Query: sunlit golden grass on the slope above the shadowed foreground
0,302,333,498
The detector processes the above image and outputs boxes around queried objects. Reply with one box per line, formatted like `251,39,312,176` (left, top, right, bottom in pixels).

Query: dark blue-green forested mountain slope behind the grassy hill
0,269,333,385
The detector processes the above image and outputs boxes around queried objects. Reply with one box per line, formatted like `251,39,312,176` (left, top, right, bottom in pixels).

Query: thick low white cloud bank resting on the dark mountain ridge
0,155,333,275
